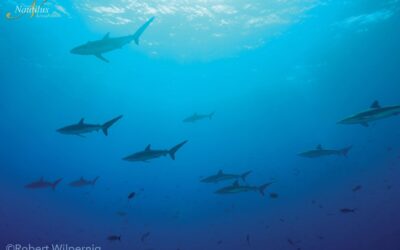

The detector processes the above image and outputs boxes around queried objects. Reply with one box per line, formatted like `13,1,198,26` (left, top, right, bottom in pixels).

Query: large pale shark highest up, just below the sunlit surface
70,17,155,63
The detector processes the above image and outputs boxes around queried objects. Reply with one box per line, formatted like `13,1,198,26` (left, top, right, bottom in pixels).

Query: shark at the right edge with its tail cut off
338,101,400,127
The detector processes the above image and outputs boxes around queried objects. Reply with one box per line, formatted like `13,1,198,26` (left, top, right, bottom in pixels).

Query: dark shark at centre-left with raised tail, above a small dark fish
122,140,188,162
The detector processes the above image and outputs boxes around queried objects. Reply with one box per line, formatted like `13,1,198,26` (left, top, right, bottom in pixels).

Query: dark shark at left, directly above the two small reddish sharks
57,115,122,137
